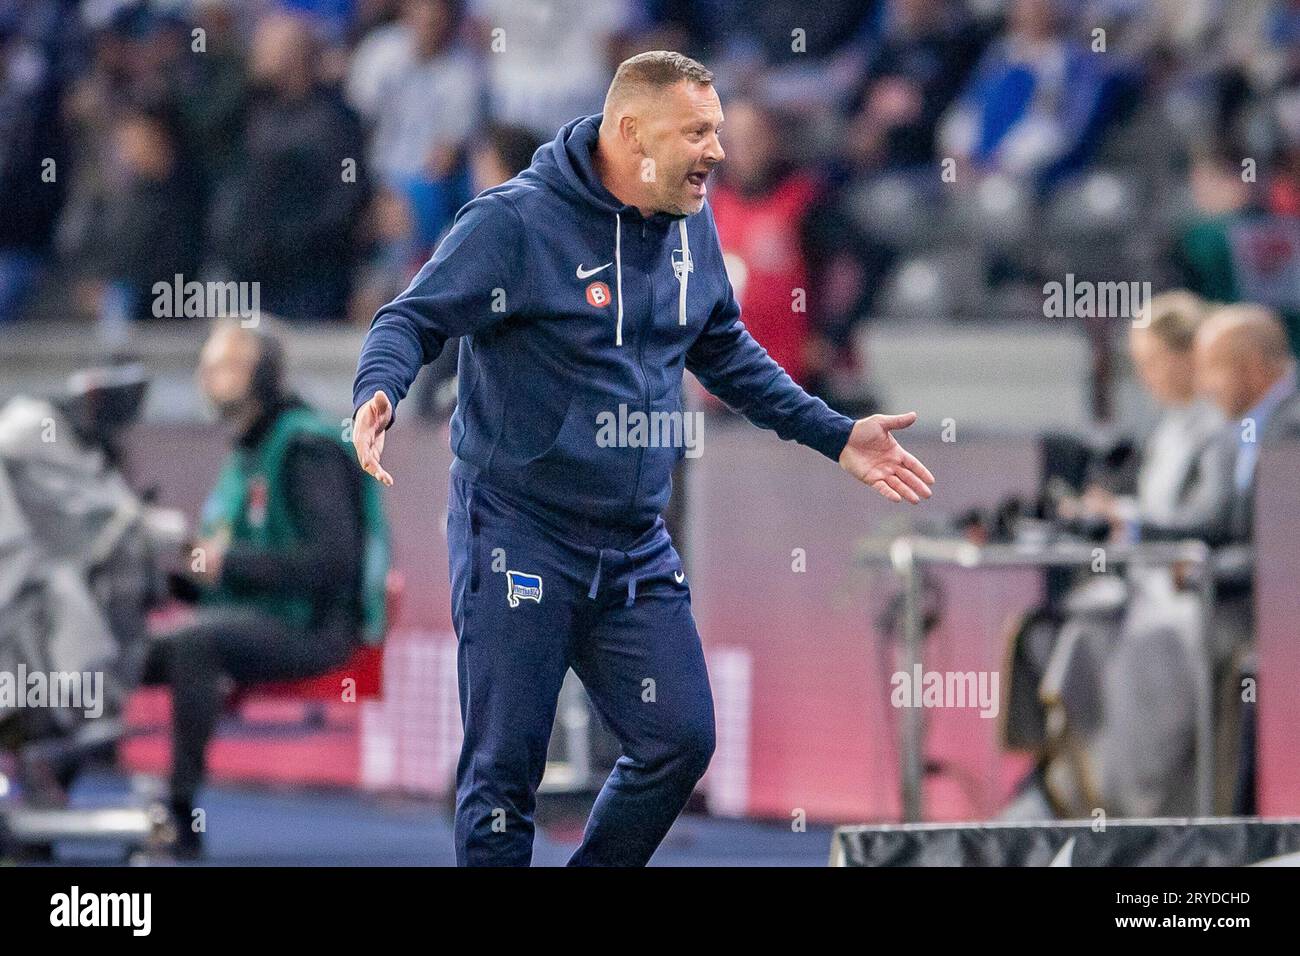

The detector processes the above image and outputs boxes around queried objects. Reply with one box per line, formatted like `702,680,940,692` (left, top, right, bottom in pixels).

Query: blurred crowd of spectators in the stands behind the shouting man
0,0,1300,416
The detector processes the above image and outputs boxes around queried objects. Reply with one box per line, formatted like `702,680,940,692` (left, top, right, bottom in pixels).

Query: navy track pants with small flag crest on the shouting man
447,473,714,866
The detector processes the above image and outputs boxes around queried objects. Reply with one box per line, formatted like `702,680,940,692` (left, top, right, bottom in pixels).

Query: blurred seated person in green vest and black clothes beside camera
146,321,389,857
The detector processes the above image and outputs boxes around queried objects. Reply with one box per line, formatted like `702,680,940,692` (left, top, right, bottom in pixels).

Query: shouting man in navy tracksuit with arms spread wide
354,51,933,865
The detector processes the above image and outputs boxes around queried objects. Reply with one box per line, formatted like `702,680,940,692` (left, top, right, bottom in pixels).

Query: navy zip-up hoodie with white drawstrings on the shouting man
352,113,853,531
